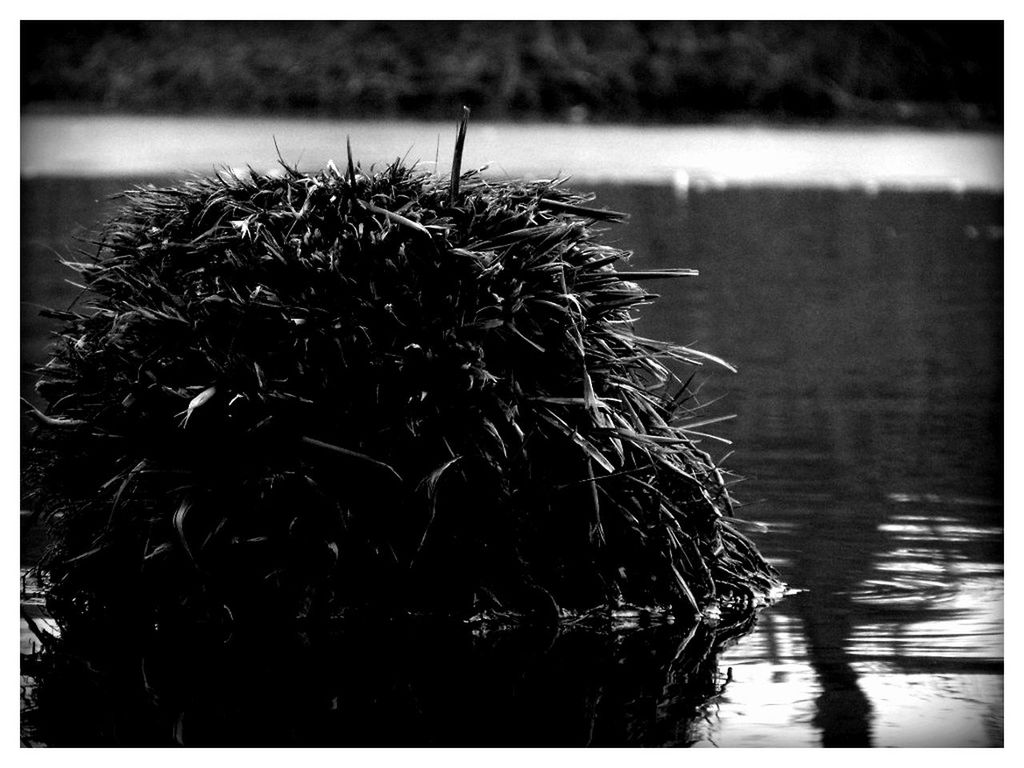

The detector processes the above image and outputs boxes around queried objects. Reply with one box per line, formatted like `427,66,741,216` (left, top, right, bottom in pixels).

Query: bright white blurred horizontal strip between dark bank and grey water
20,115,1004,194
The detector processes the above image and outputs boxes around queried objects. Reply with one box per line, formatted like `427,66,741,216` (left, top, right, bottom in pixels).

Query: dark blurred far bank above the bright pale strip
22,20,1004,129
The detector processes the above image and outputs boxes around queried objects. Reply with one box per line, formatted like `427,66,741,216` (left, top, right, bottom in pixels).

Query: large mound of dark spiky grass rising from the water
27,132,779,621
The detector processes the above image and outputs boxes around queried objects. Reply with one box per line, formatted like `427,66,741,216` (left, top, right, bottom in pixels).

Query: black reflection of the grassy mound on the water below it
23,621,765,746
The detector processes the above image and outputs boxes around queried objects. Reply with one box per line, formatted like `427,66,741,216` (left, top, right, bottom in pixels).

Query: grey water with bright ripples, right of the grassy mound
589,183,1004,745
